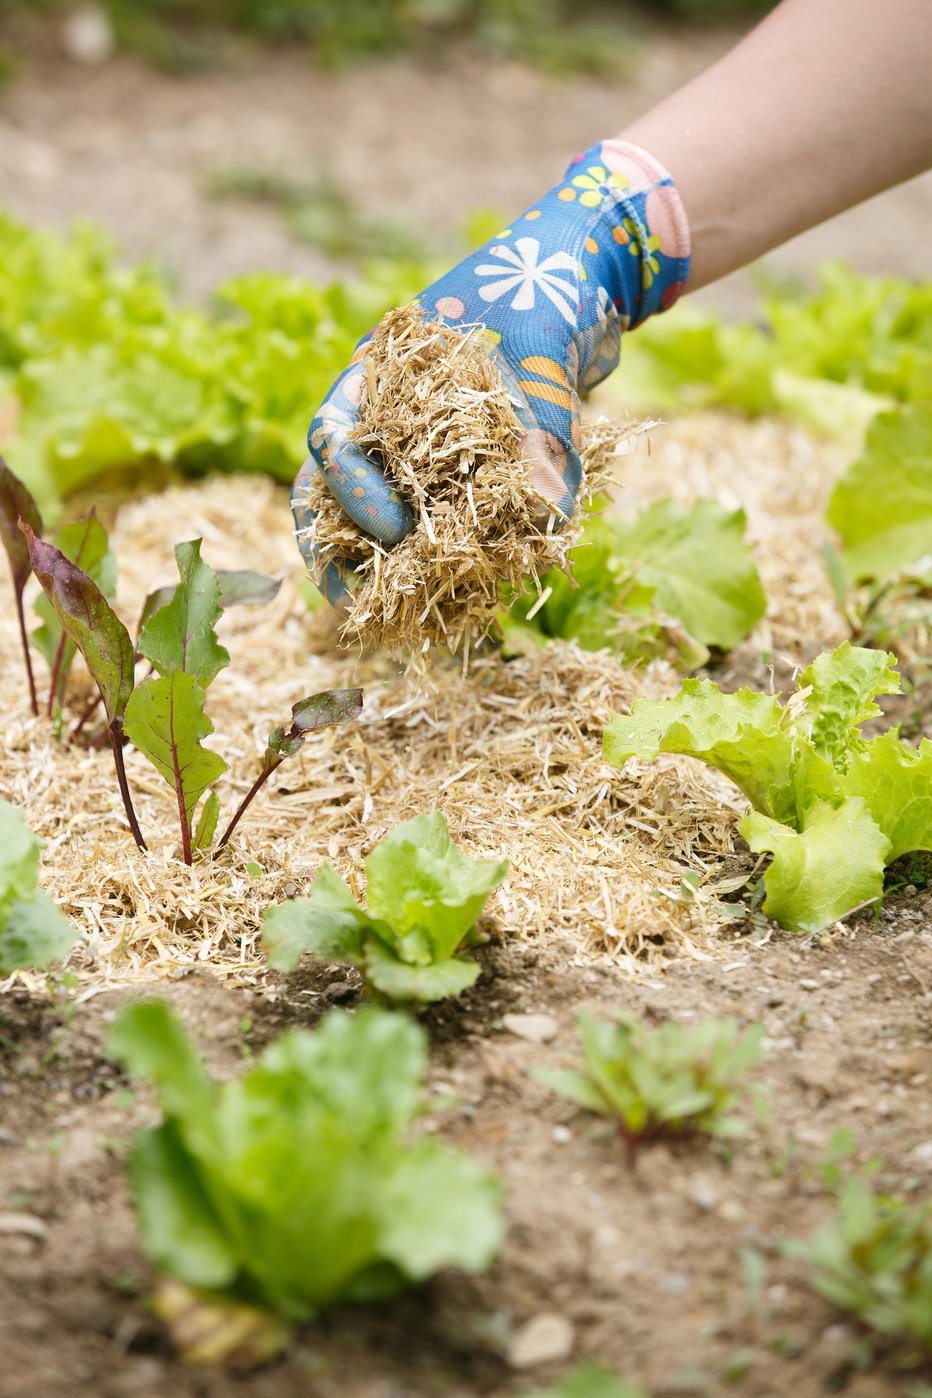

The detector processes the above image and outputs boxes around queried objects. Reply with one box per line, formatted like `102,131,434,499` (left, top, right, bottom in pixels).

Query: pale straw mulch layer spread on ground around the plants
0,417,855,994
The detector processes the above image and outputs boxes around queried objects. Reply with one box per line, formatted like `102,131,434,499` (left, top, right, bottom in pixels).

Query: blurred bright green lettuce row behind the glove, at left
0,206,436,514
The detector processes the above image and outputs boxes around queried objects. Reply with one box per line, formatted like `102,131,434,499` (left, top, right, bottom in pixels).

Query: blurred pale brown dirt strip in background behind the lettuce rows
0,27,932,313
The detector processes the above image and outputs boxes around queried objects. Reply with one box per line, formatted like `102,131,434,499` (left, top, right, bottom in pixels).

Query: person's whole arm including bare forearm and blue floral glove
293,0,932,600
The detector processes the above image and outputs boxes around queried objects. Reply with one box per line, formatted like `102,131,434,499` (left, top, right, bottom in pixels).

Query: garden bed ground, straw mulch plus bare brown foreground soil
0,415,932,1398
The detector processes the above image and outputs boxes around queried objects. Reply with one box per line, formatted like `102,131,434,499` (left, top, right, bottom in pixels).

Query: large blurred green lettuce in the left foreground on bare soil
109,1002,503,1359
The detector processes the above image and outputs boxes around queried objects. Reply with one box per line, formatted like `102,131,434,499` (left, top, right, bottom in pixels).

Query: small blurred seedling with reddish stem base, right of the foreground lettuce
534,1015,763,1159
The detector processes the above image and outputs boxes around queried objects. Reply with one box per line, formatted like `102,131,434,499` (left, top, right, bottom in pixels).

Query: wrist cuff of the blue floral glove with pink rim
558,138,690,329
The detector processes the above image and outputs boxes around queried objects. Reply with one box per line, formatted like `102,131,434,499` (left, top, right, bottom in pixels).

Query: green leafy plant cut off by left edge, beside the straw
0,797,78,976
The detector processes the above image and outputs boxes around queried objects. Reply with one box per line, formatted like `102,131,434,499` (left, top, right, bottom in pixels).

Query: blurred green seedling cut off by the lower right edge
788,1176,932,1352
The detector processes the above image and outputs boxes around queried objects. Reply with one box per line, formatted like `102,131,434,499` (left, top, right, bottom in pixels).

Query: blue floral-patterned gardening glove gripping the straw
292,141,689,605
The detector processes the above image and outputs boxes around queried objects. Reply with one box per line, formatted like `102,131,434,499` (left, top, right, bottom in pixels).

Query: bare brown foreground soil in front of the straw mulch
0,911,932,1398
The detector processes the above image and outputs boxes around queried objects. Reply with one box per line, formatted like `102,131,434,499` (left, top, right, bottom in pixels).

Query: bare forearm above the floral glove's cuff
620,0,932,289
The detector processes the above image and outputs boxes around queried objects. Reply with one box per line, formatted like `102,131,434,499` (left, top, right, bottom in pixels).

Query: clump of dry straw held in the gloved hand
309,303,598,663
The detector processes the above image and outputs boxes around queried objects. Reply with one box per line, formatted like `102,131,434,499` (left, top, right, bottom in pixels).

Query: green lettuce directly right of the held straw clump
506,499,766,668
